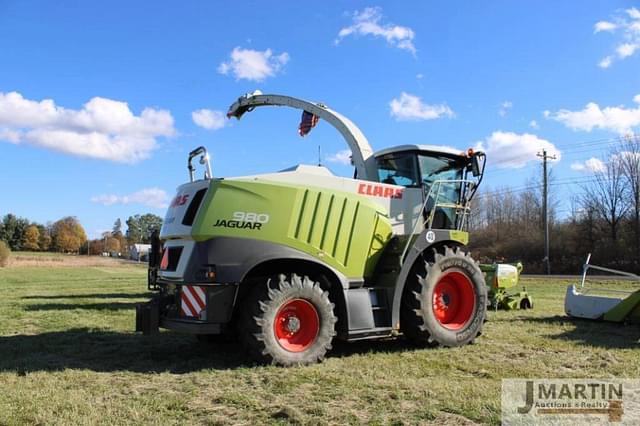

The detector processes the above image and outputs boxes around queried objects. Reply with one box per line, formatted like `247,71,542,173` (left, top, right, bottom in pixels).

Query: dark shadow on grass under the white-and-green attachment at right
523,315,640,349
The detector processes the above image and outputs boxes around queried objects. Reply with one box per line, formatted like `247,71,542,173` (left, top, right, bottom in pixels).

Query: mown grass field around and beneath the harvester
0,256,640,425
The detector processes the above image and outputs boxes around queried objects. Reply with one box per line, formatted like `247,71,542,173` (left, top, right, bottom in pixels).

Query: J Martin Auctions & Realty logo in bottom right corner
502,379,640,425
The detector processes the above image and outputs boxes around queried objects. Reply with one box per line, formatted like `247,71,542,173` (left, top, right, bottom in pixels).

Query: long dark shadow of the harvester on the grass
0,328,414,375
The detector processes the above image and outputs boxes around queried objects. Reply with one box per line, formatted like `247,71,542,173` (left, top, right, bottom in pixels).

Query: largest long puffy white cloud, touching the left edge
0,92,175,164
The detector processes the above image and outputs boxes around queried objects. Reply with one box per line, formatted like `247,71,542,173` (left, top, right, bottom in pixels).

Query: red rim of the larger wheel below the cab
433,271,476,330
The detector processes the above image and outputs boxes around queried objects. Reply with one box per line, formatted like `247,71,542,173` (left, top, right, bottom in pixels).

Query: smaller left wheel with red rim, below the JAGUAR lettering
238,273,337,366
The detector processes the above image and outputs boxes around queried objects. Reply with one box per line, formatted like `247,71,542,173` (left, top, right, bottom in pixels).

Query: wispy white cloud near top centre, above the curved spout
335,7,416,54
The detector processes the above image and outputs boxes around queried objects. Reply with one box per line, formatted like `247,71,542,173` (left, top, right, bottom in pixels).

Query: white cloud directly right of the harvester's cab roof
476,131,561,169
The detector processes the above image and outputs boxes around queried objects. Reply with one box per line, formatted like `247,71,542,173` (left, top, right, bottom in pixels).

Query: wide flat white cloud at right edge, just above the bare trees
545,95,640,135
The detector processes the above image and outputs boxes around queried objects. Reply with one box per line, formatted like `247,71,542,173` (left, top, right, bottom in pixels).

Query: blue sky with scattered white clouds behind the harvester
0,0,640,236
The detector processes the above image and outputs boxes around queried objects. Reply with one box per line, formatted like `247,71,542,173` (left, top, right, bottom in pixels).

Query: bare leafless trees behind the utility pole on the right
469,136,640,274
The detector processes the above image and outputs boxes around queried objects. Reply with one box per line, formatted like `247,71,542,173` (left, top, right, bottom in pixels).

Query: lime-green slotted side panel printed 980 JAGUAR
191,180,392,279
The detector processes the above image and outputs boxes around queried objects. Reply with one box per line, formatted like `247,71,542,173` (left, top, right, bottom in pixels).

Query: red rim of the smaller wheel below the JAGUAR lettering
273,299,320,352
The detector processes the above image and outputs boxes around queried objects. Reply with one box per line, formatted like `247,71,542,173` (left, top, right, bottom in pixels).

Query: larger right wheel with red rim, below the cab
400,247,487,347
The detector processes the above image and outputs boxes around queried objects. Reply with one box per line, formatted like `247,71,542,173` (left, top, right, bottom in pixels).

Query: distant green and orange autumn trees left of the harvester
0,213,162,255
